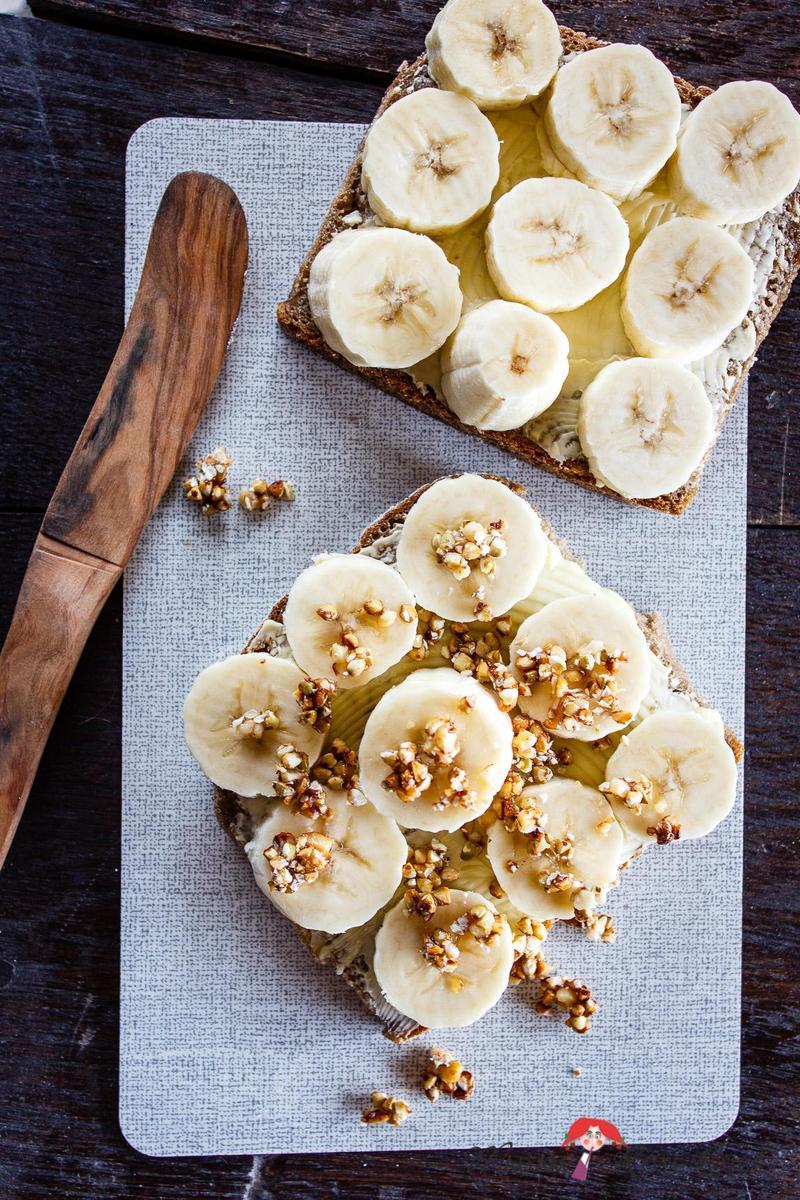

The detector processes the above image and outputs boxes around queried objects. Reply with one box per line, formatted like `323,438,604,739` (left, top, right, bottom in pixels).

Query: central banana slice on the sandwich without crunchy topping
486,179,630,312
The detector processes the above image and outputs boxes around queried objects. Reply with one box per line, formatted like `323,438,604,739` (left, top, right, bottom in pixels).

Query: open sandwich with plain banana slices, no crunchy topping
278,0,800,512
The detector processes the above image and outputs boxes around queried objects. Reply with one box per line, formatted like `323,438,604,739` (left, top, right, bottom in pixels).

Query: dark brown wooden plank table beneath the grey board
0,0,800,1200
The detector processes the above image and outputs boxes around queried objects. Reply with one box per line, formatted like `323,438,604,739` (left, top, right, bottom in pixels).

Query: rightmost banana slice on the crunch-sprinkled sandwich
601,709,736,842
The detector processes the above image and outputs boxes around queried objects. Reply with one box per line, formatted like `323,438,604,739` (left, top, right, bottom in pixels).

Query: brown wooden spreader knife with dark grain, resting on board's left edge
0,172,247,866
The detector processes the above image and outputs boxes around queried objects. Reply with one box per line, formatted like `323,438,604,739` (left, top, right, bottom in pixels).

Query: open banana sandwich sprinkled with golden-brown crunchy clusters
185,475,741,1040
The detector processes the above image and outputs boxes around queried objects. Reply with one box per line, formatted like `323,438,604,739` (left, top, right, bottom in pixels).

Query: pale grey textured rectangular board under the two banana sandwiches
120,119,746,1154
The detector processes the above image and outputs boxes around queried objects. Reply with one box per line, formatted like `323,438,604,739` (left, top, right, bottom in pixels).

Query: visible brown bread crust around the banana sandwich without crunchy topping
277,25,800,514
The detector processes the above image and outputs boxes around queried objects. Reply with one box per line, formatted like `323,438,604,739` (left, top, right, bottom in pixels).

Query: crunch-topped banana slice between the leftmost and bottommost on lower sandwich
245,793,408,934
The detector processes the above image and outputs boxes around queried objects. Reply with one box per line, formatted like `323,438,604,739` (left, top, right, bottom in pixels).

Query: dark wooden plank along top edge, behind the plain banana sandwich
31,0,798,98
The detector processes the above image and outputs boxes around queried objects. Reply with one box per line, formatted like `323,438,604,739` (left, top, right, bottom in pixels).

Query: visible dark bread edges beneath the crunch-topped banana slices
213,475,744,1044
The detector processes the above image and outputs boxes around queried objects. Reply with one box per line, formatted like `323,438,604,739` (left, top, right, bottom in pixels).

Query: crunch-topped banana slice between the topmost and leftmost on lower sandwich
283,554,416,688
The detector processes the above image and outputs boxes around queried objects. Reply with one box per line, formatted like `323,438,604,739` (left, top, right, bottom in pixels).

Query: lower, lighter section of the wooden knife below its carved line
0,533,122,866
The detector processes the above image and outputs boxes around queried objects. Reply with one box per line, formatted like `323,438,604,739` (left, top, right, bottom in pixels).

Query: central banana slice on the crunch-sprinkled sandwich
359,667,512,832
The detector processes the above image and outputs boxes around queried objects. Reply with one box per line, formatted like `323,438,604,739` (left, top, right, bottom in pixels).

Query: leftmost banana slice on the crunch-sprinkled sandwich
184,654,323,796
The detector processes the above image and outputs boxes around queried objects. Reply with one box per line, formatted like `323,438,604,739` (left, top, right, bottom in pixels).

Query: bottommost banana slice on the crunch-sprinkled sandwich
374,889,513,1030
